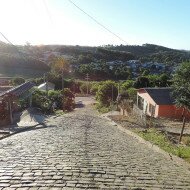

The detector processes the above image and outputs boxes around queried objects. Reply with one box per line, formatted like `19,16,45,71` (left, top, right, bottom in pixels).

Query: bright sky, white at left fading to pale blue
0,0,190,50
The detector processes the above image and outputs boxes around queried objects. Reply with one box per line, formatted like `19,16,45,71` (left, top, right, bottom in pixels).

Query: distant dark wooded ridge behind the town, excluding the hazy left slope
49,44,190,64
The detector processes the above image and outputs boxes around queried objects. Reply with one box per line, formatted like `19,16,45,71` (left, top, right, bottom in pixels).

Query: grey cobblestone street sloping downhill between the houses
0,98,190,190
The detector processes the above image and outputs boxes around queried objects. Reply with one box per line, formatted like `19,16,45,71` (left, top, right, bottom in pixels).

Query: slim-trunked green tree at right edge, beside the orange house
172,62,190,142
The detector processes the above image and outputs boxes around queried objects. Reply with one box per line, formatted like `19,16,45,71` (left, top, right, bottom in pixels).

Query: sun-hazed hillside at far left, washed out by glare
0,42,50,78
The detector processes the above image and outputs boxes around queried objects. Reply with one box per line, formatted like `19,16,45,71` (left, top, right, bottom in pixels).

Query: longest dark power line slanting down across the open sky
68,0,128,44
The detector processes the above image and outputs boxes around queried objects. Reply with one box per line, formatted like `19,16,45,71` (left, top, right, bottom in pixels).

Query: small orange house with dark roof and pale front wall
137,88,190,119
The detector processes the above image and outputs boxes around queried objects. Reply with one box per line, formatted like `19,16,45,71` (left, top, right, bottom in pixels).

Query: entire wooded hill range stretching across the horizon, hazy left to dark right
0,42,190,77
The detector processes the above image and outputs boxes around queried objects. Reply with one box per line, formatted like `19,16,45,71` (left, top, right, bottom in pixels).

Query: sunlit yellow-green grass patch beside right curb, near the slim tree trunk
135,128,190,162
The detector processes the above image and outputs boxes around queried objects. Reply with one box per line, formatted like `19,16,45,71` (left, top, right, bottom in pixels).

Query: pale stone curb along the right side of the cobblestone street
101,116,190,172
